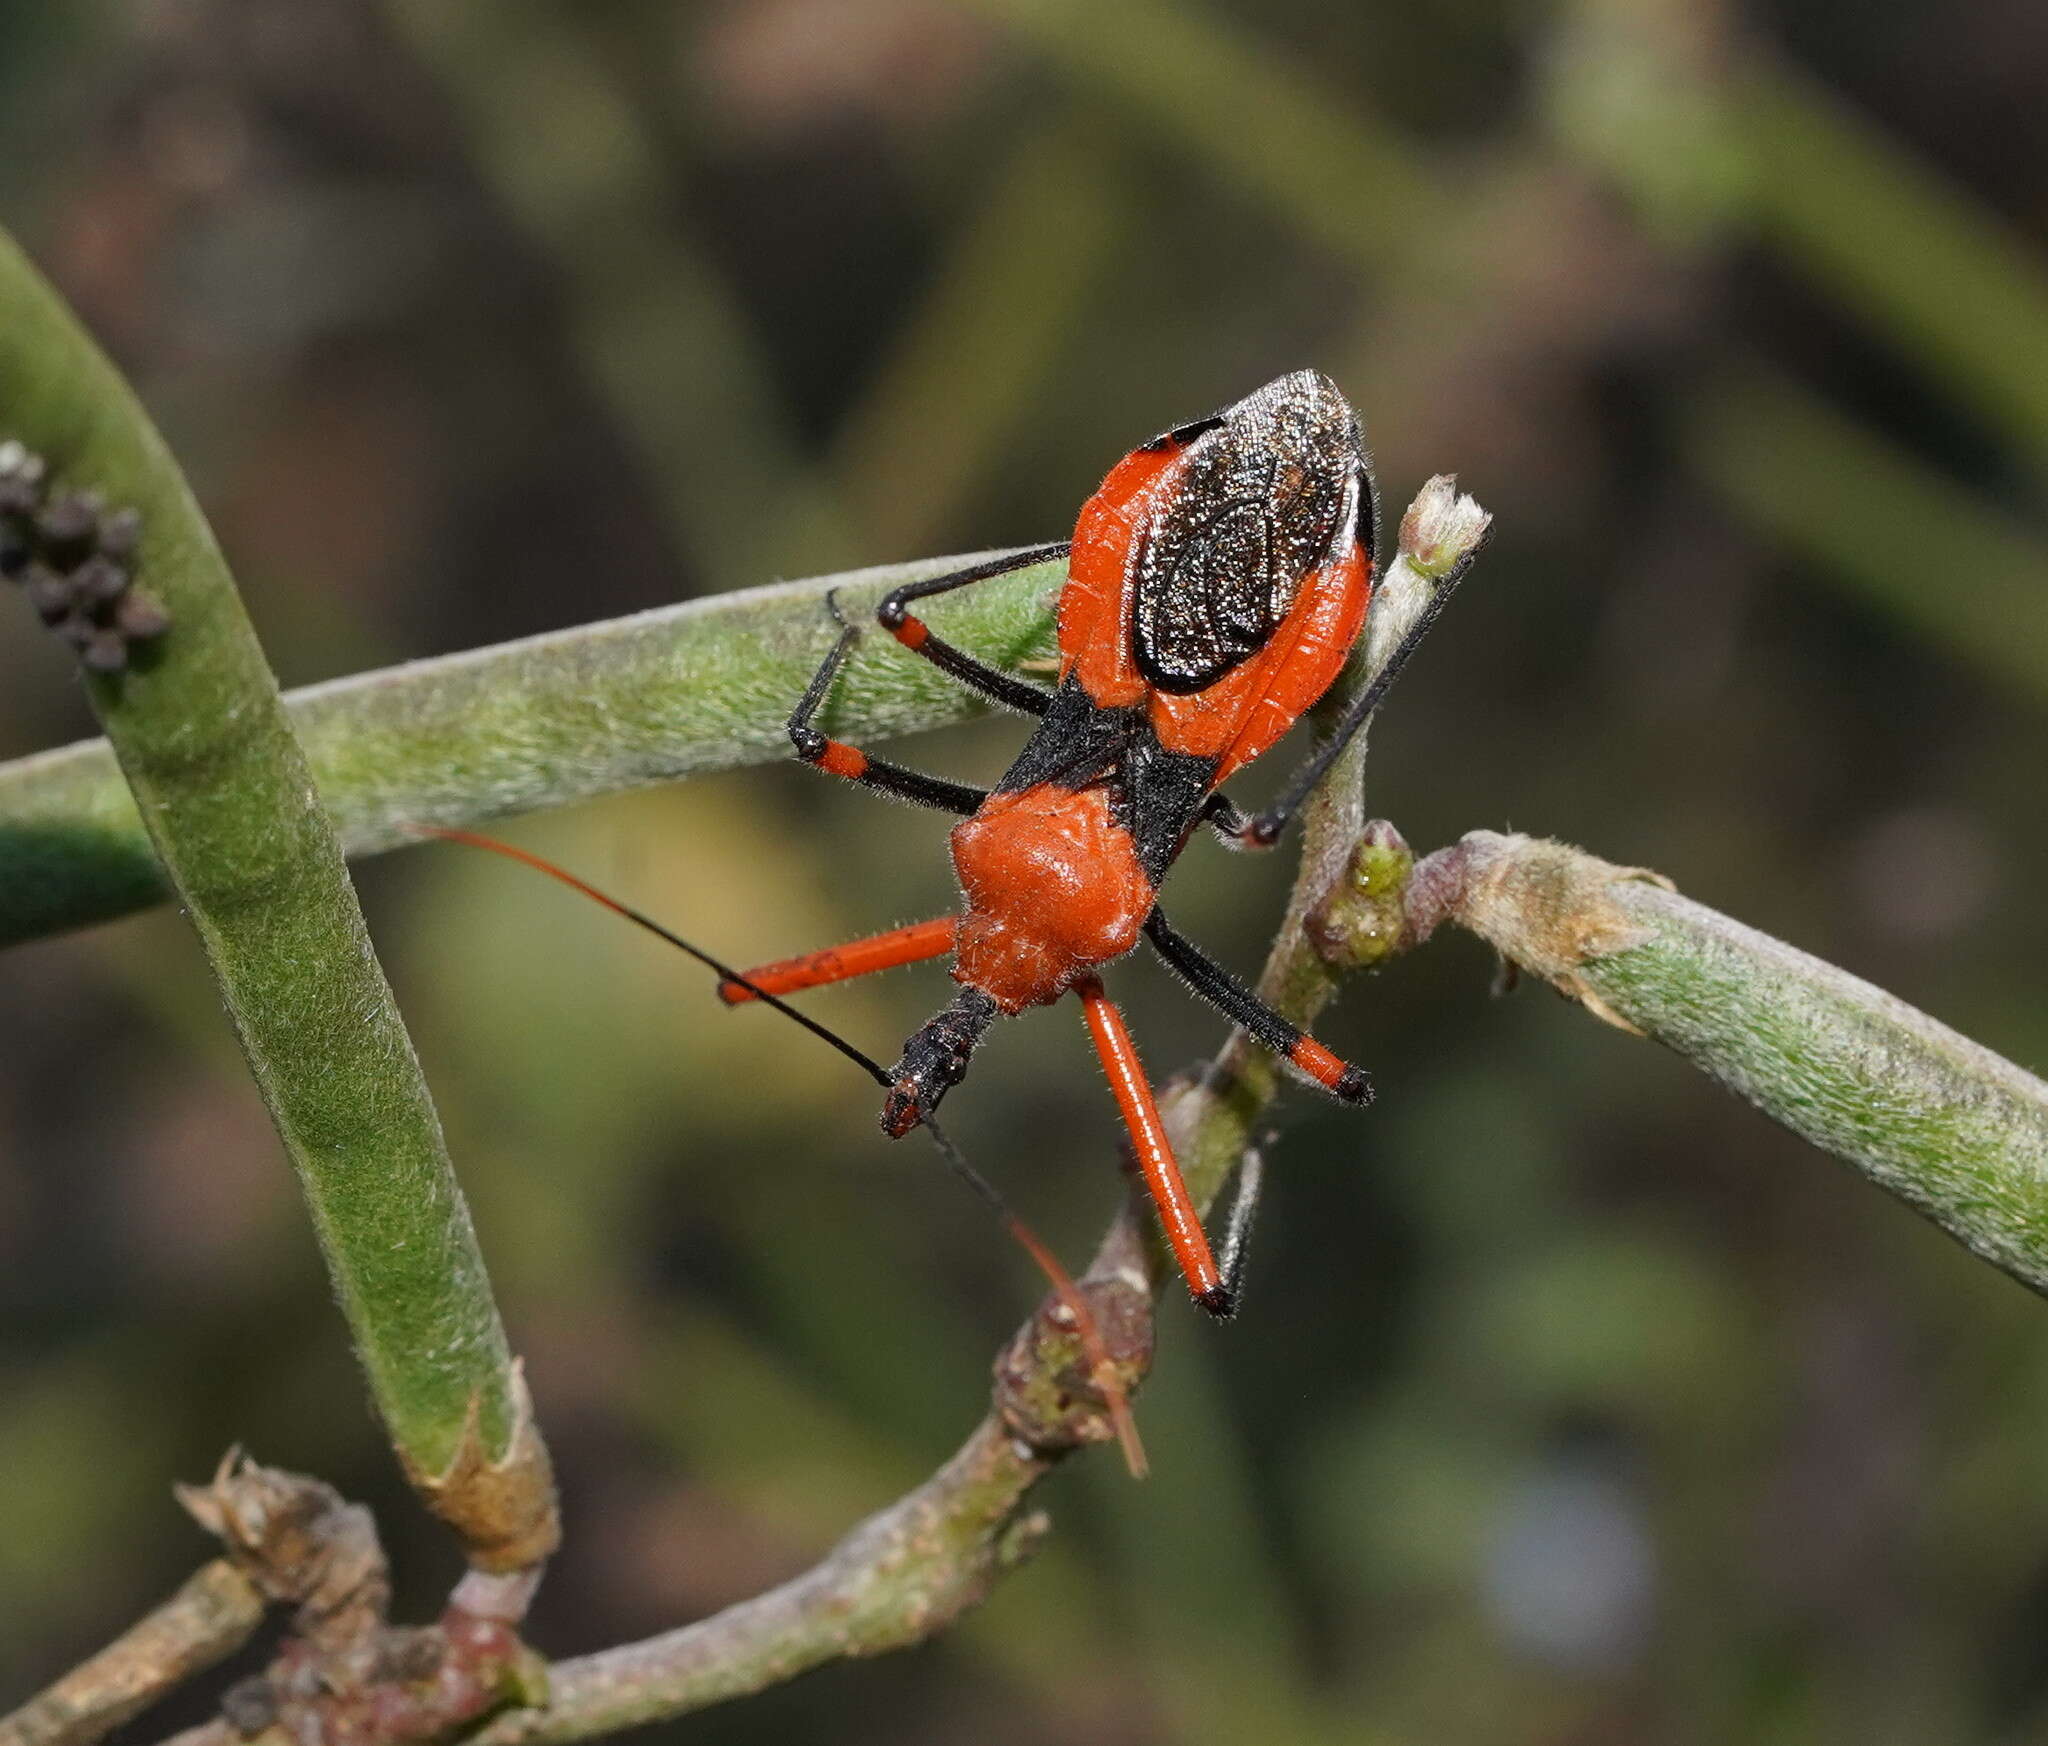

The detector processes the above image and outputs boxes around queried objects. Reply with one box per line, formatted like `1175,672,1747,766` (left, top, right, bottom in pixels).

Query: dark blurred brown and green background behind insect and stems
0,0,2048,1746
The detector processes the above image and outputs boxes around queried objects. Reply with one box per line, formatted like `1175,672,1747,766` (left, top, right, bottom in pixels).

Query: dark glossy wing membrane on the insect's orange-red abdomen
1130,370,1368,694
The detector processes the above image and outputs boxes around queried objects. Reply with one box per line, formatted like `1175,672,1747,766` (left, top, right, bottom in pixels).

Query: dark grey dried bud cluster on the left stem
0,442,170,673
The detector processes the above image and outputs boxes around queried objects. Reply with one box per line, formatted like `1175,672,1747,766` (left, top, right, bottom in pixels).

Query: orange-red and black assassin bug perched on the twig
721,370,1442,1316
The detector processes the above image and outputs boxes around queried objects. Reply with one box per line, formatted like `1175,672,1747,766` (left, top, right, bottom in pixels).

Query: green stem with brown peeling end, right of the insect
1409,831,2048,1294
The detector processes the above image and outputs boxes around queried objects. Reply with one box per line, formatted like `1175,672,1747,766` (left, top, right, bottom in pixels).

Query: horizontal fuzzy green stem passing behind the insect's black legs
0,559,1063,946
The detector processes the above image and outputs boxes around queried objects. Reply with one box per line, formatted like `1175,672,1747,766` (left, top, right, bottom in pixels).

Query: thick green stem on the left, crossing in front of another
0,225,553,1562
